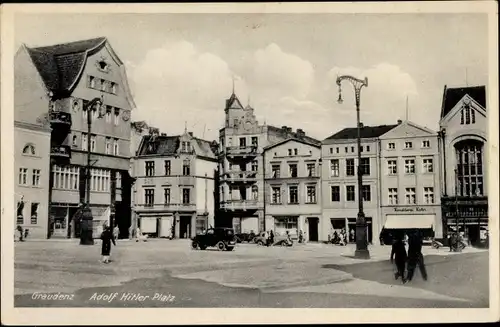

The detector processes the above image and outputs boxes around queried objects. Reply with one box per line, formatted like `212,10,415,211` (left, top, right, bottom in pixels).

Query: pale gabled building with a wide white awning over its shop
377,120,442,238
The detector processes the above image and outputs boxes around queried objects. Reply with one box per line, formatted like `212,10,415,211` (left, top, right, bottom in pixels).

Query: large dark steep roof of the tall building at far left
26,37,106,94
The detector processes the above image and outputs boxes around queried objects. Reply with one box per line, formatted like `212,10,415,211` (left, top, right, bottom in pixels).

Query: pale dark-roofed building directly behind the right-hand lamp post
321,125,397,242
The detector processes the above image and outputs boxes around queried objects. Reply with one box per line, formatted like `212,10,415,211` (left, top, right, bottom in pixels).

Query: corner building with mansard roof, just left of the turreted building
133,130,218,238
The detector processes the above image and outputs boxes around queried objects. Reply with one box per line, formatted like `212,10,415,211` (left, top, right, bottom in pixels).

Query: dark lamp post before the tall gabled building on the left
80,96,103,245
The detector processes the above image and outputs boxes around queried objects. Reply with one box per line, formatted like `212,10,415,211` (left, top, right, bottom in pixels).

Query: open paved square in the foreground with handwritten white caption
15,240,489,308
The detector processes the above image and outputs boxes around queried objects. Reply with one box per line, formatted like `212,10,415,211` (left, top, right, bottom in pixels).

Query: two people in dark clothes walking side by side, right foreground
391,231,427,284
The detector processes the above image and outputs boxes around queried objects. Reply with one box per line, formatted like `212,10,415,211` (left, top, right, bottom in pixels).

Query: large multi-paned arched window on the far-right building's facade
455,140,484,196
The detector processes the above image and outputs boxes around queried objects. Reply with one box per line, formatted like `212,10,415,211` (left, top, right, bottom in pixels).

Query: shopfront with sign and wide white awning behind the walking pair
381,205,443,238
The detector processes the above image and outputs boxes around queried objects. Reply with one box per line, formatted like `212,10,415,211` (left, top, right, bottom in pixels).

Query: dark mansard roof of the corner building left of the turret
137,135,216,159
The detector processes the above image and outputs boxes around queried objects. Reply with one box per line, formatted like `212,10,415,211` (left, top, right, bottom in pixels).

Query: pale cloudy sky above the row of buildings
15,14,488,139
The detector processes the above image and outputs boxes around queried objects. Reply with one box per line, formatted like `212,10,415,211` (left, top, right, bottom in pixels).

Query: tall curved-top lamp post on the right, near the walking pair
337,75,370,259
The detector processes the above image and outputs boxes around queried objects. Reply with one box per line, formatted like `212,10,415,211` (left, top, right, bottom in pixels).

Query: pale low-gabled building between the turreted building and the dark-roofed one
263,138,321,241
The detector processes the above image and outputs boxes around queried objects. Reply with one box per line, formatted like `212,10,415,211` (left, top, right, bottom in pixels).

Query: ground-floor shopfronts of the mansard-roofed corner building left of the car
136,212,209,239
